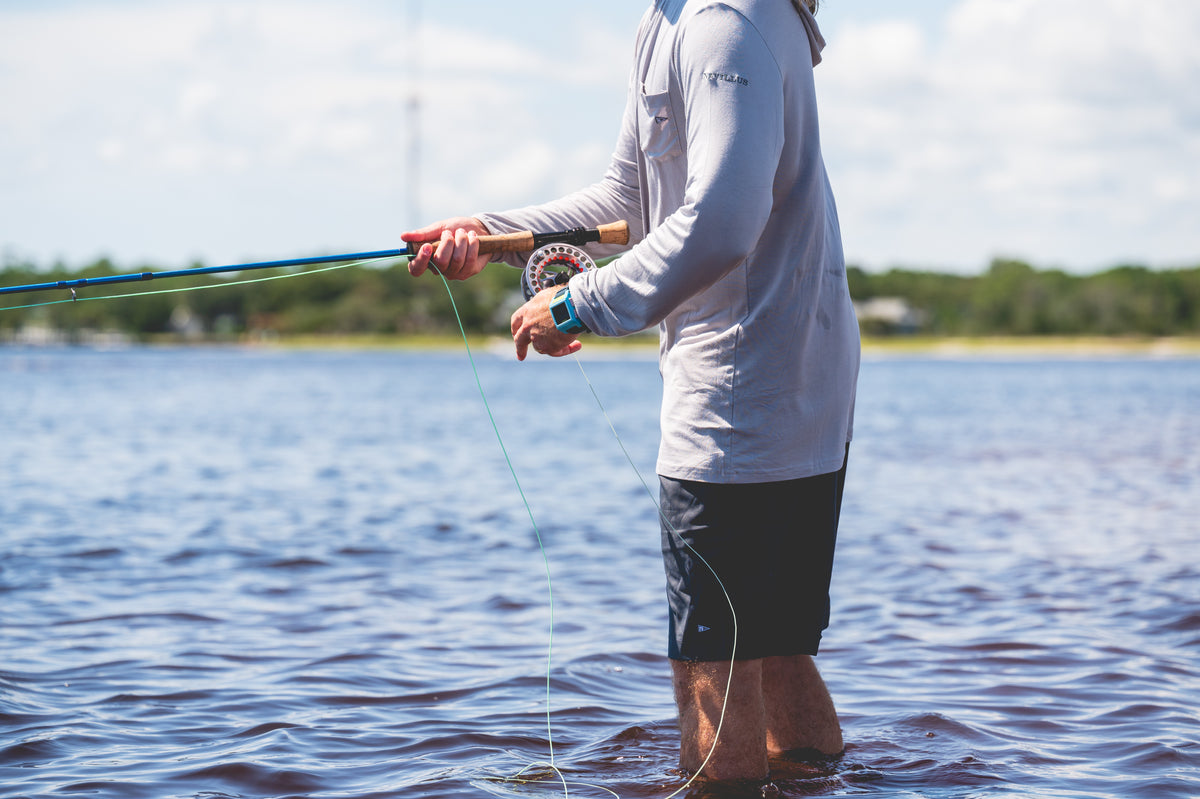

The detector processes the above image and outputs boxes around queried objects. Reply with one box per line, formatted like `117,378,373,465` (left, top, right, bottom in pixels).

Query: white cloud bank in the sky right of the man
820,0,1200,270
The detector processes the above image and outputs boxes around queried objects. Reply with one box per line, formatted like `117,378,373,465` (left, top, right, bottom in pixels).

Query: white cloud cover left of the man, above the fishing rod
0,0,640,263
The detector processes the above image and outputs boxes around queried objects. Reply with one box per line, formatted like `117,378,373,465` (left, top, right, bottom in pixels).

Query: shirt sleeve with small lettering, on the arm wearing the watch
571,6,784,336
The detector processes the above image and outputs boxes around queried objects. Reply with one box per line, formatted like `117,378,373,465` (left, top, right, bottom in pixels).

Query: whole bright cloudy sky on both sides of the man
0,0,1200,274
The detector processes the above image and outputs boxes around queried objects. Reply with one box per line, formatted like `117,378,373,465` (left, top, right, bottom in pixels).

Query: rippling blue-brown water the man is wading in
0,348,1200,799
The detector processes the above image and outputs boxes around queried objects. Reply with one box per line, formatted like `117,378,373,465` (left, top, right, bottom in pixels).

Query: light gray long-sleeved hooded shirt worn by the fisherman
479,0,859,482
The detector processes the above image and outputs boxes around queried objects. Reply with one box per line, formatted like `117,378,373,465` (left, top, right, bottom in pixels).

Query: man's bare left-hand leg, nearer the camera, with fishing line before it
671,660,768,780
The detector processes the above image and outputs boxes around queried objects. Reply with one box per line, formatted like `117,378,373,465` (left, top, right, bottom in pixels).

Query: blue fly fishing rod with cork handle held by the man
0,222,629,294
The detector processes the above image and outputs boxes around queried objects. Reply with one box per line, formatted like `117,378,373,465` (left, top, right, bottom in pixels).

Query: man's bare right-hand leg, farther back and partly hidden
762,655,845,755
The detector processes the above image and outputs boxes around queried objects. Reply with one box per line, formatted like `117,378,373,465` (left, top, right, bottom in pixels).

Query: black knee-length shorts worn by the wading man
659,451,848,661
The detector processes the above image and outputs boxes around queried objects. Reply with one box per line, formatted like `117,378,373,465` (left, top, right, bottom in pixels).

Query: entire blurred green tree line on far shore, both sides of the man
0,260,1200,341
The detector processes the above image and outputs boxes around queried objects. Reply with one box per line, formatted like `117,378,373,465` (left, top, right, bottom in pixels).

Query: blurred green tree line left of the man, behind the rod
0,260,521,341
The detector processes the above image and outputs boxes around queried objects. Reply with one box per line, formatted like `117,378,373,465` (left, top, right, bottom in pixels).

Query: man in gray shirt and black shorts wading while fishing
403,0,859,780
